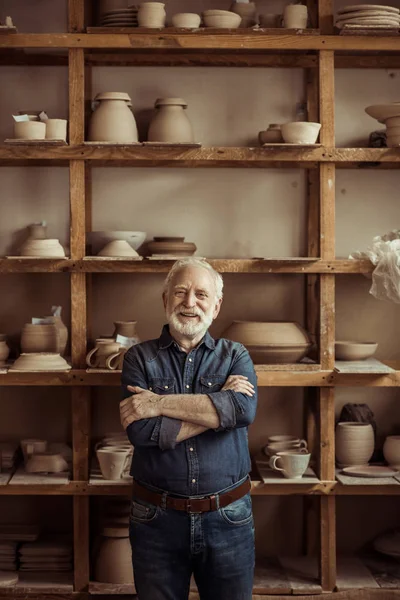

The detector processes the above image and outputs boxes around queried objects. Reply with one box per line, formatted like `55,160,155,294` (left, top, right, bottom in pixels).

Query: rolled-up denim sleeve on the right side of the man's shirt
207,346,257,431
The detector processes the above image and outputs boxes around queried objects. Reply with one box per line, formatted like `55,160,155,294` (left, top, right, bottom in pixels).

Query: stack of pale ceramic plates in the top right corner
336,4,400,30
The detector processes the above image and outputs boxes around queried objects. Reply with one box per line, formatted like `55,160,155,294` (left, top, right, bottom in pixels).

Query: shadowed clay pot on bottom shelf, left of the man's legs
94,528,133,584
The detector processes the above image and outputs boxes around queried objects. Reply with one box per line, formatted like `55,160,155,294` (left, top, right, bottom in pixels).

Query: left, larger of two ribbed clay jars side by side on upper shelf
89,92,138,144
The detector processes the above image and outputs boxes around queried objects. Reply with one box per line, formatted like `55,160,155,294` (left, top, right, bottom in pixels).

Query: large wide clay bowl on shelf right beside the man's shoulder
221,321,310,347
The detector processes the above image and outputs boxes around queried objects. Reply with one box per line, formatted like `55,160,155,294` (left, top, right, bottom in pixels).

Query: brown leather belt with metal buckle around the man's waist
133,477,251,513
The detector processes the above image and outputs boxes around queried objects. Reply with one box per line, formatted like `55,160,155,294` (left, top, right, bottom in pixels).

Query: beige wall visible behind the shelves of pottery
0,0,400,554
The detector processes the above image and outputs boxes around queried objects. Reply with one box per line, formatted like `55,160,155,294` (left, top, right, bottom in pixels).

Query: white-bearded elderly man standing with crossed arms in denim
120,258,257,600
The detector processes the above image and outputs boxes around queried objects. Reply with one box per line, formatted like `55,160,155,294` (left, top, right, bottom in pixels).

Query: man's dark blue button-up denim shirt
122,325,257,496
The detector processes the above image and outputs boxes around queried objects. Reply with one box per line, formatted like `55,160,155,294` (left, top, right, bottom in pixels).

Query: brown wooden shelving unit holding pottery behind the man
0,0,400,598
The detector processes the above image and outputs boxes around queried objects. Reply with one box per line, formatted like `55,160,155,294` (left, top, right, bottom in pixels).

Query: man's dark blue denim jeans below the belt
130,494,254,600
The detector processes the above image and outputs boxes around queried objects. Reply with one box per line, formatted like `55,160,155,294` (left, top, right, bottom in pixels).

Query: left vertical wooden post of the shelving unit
68,0,90,592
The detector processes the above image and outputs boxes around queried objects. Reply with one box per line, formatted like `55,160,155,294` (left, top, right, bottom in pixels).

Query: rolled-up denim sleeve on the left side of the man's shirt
121,347,182,450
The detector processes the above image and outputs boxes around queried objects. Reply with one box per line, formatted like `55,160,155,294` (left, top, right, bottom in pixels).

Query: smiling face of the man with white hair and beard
163,267,222,340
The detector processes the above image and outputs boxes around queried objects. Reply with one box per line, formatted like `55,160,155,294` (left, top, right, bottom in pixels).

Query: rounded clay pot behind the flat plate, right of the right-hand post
335,422,375,467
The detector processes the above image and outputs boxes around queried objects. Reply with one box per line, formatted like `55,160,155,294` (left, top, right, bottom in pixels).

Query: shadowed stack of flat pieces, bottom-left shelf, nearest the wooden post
19,540,72,571
